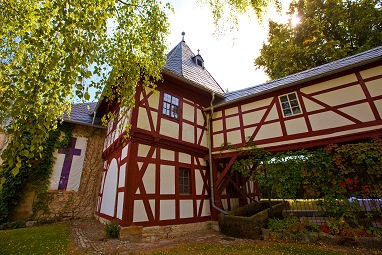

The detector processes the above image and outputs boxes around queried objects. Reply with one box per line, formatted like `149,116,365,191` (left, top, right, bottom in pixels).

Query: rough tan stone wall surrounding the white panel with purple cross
13,125,105,220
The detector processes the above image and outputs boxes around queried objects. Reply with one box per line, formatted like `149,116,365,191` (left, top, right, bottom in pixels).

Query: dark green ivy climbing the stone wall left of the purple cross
0,124,72,223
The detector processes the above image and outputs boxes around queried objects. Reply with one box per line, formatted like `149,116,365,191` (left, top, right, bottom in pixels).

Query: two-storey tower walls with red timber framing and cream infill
97,73,216,226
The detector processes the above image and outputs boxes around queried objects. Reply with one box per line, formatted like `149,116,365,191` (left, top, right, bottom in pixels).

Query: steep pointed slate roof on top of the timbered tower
164,41,224,96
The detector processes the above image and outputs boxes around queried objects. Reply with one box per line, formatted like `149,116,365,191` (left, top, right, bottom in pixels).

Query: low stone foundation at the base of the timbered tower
120,221,212,242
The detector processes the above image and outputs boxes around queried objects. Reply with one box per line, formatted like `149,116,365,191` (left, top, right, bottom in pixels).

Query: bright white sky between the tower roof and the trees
167,0,290,91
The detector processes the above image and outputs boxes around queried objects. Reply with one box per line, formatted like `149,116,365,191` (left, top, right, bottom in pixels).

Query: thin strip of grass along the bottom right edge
147,243,382,255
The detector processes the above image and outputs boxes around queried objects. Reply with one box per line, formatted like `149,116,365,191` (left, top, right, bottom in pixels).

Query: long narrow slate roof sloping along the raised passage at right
217,46,382,105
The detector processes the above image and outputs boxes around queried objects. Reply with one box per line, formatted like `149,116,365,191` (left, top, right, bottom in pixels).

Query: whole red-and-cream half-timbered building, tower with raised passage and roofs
96,36,382,230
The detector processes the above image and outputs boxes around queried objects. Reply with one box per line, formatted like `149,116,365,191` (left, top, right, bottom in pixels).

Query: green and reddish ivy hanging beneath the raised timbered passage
231,140,382,199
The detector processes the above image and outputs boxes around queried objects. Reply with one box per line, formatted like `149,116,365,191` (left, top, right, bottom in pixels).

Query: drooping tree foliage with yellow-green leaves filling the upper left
0,0,169,183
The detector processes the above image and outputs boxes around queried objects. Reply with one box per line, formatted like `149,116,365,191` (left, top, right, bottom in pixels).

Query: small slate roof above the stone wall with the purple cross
64,102,102,127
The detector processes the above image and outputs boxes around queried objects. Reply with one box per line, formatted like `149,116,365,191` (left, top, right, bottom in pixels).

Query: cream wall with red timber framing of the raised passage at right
213,62,382,155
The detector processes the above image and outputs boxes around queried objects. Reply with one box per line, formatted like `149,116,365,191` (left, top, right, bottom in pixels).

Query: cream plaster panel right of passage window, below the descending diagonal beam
309,112,353,131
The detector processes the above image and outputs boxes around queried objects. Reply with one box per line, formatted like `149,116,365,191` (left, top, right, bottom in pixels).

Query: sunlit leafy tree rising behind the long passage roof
255,0,382,79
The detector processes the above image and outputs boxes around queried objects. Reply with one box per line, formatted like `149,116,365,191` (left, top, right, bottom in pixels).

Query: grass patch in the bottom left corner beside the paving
0,224,71,254
